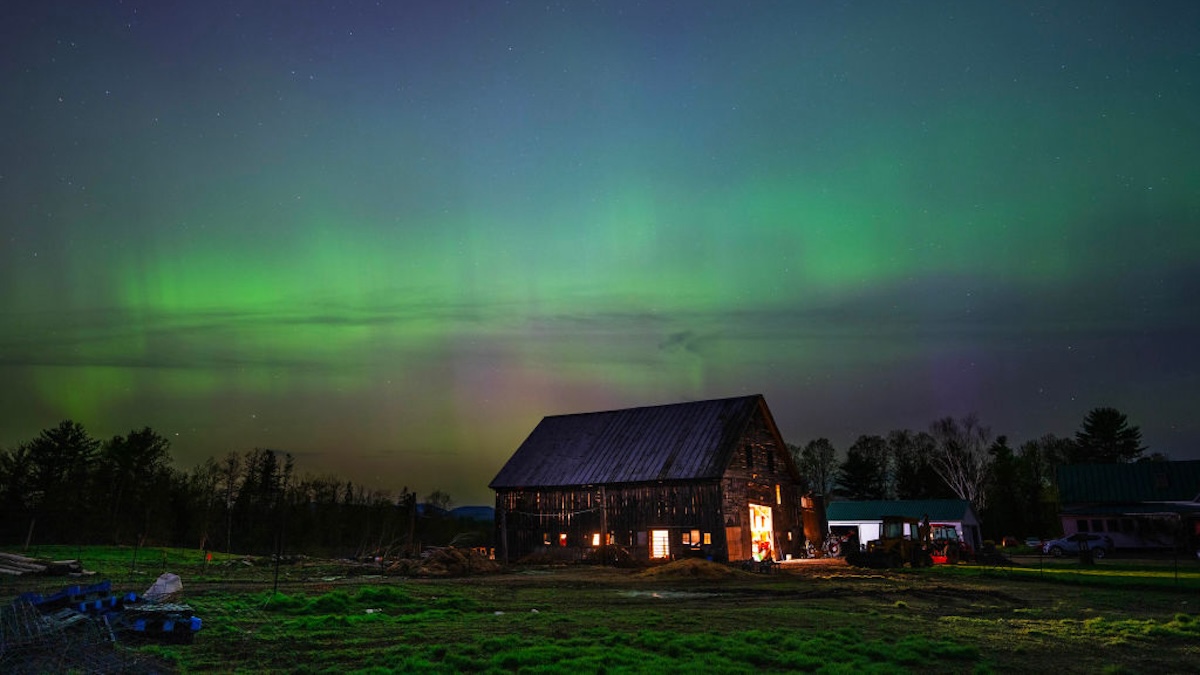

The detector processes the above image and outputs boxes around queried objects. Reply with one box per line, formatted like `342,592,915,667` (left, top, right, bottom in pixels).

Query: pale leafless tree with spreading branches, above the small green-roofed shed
929,413,991,513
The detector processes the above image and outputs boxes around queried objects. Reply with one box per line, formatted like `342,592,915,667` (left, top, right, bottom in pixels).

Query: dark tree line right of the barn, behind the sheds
788,407,1165,540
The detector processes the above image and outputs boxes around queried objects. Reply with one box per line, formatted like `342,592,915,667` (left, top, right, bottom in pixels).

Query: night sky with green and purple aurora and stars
0,0,1200,504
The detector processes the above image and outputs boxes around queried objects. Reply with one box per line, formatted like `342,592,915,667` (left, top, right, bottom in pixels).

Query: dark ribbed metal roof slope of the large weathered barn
488,394,774,490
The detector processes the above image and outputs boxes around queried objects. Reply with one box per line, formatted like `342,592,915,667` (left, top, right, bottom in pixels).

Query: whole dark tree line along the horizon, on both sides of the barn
0,407,1164,556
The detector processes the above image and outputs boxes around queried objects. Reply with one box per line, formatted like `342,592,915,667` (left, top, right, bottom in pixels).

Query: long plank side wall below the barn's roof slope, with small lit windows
496,482,728,561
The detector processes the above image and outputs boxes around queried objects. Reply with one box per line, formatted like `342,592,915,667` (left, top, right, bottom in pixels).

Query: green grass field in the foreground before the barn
0,549,1200,673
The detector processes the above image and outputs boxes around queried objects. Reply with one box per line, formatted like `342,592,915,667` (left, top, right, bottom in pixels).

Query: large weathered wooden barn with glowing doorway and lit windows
490,395,820,562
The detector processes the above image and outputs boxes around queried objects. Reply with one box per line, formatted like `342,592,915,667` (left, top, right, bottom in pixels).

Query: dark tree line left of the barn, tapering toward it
0,420,468,557
